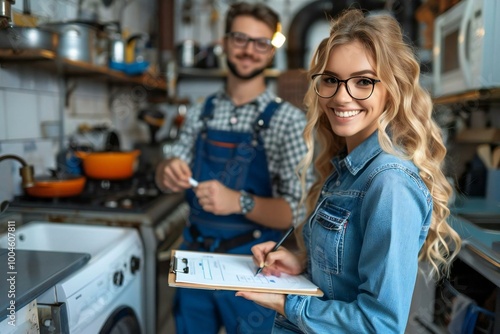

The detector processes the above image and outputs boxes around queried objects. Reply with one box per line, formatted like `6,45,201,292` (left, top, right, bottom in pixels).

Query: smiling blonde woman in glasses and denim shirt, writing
237,10,460,333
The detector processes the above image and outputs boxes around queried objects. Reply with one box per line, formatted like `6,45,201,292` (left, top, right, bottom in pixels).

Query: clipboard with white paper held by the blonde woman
168,250,323,297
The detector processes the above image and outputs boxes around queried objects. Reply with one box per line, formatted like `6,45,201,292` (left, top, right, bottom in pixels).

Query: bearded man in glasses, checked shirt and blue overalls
156,3,312,334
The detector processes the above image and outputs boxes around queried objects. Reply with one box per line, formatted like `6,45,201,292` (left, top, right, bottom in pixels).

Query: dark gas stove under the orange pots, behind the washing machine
7,175,189,334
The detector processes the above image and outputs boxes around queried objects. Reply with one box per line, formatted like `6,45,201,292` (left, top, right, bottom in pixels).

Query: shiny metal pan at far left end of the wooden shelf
0,26,59,52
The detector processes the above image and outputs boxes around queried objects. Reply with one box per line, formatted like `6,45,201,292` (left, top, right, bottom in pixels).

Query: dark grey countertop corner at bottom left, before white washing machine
0,249,90,322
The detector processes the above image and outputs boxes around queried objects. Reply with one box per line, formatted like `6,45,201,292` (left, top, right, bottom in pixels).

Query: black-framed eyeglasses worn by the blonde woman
311,73,380,100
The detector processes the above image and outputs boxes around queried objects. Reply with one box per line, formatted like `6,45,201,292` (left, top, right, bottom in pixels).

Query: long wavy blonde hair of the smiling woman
299,9,461,278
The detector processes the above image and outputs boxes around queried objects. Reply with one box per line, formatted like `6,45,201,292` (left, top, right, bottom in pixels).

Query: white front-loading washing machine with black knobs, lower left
0,222,145,334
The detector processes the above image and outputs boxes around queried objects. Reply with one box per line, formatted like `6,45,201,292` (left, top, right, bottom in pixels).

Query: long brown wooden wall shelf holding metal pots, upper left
0,49,167,91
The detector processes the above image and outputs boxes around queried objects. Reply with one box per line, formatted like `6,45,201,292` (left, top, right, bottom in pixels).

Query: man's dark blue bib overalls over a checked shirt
174,95,282,334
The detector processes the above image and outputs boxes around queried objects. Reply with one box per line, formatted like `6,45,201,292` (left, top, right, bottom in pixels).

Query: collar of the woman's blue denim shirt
332,130,382,175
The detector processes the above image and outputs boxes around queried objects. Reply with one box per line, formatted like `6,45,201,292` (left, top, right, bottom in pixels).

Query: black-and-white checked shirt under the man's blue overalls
170,90,313,225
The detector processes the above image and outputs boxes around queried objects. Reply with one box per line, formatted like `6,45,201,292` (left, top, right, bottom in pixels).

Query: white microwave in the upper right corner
433,0,500,97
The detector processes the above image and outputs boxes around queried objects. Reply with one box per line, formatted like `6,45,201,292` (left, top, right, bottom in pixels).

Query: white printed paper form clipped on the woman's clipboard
175,251,318,291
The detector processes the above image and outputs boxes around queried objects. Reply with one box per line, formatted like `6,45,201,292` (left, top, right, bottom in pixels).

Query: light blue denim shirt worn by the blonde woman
273,132,432,333
